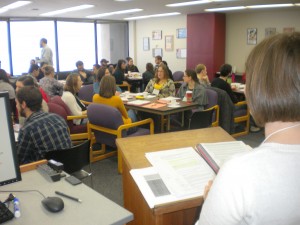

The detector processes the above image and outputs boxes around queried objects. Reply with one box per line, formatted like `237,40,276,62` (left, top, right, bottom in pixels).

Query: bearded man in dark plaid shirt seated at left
16,86,72,164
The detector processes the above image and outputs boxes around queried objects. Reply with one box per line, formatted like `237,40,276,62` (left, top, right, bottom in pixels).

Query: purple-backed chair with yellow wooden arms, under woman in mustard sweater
87,103,154,173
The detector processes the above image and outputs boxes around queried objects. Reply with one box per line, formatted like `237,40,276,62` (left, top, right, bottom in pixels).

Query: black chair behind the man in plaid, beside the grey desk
45,140,93,186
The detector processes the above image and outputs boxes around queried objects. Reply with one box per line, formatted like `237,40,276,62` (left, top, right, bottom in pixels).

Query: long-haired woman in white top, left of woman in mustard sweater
61,73,86,125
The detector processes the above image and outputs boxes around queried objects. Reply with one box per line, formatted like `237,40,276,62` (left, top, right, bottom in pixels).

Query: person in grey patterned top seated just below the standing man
40,66,64,98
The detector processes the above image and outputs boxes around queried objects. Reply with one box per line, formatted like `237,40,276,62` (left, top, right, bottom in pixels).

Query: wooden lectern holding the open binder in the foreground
117,127,235,225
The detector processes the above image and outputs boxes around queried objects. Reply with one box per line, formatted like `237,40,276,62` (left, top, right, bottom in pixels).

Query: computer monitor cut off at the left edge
0,92,21,186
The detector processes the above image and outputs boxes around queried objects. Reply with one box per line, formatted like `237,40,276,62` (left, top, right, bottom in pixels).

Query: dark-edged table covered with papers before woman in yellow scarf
124,98,198,133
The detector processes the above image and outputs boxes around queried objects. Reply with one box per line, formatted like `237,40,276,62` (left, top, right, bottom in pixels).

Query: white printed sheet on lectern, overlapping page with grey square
146,147,215,198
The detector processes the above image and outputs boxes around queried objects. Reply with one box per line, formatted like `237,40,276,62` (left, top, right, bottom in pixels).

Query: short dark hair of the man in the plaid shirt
17,86,43,112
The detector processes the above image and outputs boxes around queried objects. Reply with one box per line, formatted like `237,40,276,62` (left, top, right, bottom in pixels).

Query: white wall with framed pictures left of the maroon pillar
129,15,186,72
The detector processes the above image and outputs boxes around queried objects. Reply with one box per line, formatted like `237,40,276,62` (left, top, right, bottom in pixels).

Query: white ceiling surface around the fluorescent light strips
0,0,300,20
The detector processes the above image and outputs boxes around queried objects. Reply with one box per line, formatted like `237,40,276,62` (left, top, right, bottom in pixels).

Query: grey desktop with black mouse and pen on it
0,170,133,225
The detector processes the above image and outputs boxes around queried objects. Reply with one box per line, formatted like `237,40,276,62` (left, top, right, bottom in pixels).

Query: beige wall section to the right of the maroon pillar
225,7,300,72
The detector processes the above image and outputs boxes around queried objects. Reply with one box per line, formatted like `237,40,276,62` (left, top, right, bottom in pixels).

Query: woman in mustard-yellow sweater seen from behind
93,76,137,133
